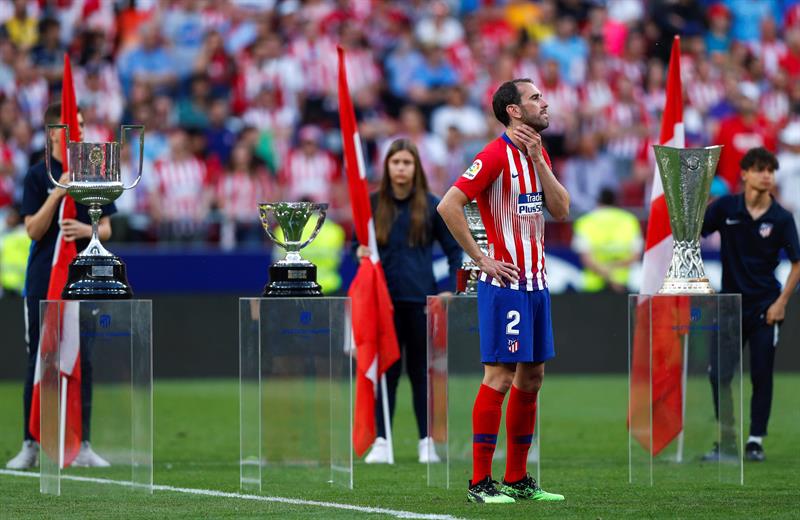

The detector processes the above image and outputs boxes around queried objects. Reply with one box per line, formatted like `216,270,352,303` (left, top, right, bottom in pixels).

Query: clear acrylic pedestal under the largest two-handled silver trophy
37,300,153,495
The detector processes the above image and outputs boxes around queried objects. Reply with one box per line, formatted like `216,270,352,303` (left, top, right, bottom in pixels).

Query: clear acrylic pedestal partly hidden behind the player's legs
427,295,542,489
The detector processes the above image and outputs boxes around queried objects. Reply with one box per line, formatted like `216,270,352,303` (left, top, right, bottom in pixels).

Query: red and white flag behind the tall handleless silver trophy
629,36,688,455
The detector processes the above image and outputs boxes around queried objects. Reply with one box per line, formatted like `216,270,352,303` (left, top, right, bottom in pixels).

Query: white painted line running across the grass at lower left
0,469,460,520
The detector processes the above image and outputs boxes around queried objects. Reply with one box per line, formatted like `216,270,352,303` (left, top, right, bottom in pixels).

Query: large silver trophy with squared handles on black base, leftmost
45,125,144,300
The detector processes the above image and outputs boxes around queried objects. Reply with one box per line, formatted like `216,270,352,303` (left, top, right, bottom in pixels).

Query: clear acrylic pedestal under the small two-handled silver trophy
239,297,353,491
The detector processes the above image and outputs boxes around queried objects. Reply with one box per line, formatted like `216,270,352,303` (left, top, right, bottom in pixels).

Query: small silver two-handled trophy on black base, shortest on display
258,202,328,297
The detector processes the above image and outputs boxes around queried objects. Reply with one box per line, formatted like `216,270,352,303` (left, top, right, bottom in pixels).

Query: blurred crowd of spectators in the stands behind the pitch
0,0,800,292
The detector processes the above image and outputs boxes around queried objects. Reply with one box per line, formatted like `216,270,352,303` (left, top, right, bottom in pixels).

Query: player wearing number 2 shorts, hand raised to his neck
438,79,569,503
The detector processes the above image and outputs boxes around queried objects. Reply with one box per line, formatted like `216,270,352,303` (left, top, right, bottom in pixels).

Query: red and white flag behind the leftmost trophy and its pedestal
28,53,82,466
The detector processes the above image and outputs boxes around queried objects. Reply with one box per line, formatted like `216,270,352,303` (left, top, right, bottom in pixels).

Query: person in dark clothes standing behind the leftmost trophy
6,103,117,469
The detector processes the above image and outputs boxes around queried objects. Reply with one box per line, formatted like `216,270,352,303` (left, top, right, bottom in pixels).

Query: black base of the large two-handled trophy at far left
61,255,133,300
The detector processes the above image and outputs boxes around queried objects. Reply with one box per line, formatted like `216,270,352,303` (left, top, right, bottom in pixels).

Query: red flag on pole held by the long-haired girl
336,46,400,456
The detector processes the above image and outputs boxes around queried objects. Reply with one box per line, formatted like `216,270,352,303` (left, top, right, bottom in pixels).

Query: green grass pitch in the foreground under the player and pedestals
0,374,800,520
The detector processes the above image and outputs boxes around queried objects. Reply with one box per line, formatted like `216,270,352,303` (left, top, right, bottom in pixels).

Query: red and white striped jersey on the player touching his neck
454,134,551,291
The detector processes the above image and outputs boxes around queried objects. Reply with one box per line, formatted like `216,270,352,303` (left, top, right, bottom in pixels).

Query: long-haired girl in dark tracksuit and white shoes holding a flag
356,139,463,464
